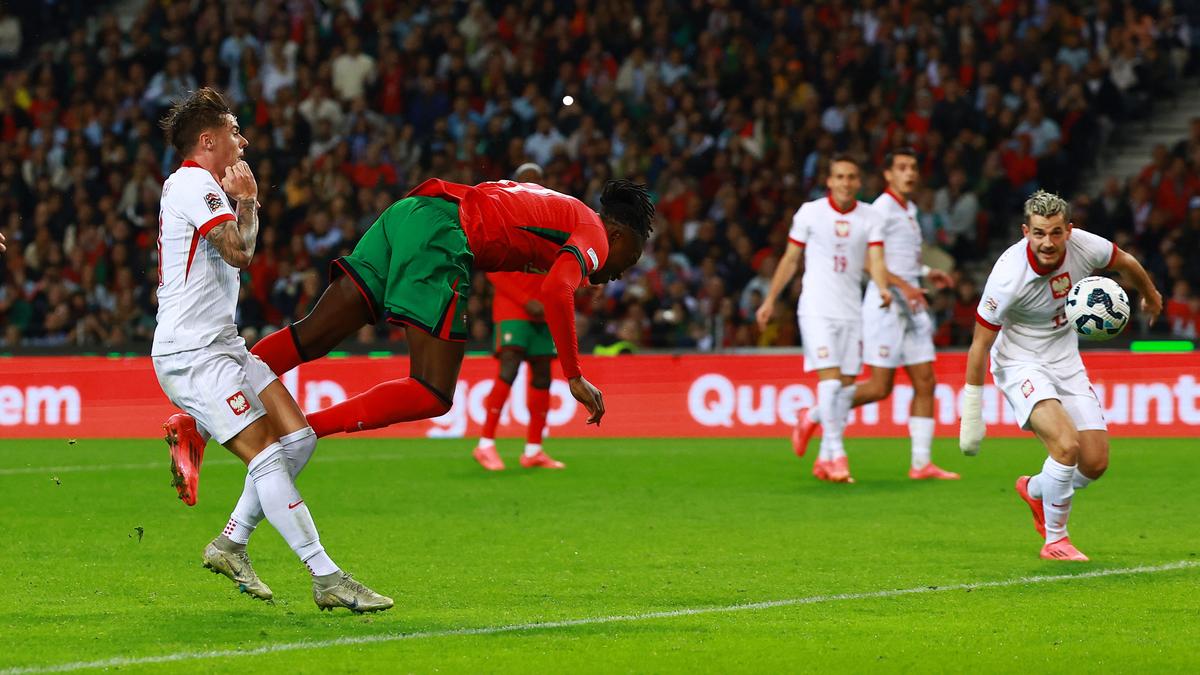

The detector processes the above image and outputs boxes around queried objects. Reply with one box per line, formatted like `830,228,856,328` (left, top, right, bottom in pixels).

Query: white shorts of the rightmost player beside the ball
991,360,1109,431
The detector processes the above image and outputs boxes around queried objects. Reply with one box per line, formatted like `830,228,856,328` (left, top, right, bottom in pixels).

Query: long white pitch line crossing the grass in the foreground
0,560,1200,675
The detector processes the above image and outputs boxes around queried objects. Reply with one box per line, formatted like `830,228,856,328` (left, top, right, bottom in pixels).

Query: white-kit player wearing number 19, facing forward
756,155,892,483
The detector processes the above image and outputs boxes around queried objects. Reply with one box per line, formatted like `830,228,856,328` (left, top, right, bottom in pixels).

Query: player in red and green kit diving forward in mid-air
163,179,654,492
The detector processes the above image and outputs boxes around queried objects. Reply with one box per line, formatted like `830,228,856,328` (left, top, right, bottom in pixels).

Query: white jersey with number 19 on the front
787,197,883,323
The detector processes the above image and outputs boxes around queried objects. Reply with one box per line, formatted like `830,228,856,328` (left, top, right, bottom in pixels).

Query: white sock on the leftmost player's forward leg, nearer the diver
247,443,337,575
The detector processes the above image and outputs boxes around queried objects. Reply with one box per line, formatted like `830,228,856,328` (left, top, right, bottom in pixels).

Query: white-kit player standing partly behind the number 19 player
792,148,959,480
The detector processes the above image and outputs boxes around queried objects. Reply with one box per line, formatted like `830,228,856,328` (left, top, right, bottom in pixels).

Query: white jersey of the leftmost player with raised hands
150,161,240,357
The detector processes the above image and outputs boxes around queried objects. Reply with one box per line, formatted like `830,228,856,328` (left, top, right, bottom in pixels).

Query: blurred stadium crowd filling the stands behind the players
0,0,1200,350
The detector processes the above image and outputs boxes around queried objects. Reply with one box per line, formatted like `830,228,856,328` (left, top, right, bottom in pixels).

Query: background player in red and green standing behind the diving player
473,271,564,471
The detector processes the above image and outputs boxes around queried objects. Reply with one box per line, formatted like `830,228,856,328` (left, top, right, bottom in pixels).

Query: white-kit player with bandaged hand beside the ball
959,190,1163,561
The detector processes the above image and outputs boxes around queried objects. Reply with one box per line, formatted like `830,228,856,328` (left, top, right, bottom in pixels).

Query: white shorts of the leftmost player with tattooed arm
151,338,276,443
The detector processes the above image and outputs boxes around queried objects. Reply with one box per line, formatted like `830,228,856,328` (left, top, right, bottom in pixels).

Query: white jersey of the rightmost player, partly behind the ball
976,227,1117,369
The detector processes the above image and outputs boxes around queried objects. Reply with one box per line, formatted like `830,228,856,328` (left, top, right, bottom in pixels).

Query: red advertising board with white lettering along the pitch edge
0,352,1200,438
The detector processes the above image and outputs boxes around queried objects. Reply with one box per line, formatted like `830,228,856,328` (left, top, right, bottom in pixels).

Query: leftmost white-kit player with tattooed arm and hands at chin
151,88,392,613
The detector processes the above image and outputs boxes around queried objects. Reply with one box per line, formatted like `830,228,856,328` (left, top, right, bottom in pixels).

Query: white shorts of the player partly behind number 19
863,291,937,370
